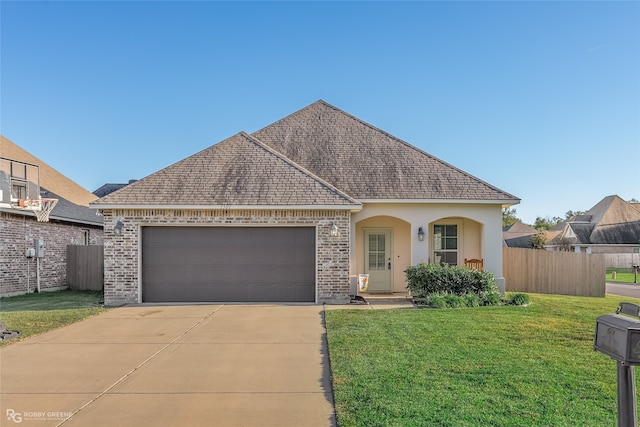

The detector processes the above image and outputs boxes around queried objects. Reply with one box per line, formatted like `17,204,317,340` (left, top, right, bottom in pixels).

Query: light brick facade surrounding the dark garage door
103,209,351,306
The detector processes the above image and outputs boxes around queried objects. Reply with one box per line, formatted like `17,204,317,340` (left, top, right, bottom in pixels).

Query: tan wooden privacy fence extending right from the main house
502,248,606,297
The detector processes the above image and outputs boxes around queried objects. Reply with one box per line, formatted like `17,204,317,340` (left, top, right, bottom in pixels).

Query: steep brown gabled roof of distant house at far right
549,195,640,245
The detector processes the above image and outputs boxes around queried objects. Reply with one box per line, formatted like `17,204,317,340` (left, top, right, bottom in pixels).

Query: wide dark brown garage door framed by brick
142,227,316,302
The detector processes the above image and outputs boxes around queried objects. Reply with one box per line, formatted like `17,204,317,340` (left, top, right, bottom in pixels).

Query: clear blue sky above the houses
0,0,640,222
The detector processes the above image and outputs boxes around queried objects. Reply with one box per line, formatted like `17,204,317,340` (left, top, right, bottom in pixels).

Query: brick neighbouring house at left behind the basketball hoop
0,136,103,296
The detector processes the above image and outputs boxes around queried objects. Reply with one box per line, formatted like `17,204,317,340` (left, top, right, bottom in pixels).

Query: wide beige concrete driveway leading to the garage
0,305,335,427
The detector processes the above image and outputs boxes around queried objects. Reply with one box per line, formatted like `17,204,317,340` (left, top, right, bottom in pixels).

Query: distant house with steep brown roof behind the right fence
545,195,640,254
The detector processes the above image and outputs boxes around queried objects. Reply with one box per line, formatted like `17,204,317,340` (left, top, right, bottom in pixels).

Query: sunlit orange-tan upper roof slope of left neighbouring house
0,135,97,206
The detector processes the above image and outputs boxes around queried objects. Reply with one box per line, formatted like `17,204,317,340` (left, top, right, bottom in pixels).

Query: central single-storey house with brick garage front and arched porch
91,101,519,305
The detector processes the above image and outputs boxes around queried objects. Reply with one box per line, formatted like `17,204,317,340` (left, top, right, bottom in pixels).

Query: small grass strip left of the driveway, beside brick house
0,290,106,346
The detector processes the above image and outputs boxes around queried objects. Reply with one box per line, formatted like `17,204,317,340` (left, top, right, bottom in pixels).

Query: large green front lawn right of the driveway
326,294,640,427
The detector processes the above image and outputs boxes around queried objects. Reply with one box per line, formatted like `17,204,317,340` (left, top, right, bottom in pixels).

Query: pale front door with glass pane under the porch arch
364,228,393,292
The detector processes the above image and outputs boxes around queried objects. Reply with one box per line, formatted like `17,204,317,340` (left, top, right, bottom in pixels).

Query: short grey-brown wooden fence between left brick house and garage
67,245,104,291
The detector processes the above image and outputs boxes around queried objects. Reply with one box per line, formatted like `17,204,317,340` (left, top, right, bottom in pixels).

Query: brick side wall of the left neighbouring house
0,212,103,296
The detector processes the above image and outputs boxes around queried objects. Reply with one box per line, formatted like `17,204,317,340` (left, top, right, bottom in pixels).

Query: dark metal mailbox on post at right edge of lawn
594,302,640,365
